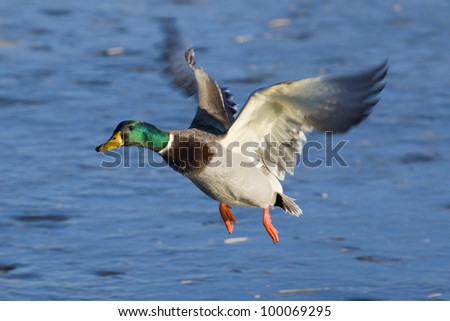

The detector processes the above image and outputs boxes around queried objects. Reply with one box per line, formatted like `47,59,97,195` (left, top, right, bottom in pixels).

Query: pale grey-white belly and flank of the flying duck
186,159,283,208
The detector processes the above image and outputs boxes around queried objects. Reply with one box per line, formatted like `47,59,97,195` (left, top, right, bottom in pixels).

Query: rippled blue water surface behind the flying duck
0,0,450,300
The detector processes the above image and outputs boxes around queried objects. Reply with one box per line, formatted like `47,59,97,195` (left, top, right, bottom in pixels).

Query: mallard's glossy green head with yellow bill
95,120,169,152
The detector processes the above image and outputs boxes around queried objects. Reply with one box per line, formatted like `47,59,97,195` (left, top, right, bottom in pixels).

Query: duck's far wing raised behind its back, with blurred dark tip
162,19,237,135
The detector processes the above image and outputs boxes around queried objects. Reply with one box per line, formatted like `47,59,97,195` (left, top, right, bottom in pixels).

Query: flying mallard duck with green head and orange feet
96,49,387,243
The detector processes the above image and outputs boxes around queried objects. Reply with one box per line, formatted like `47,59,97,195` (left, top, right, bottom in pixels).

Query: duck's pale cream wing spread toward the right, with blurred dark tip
222,61,388,180
